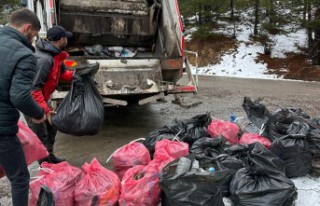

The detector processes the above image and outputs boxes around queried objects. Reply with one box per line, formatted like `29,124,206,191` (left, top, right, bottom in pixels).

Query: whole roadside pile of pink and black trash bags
30,98,320,206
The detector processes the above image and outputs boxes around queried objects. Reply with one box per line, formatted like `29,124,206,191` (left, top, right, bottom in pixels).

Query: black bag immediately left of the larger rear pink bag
179,113,212,146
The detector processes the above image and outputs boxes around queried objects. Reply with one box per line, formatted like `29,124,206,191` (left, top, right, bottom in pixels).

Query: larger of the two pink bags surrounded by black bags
208,119,239,144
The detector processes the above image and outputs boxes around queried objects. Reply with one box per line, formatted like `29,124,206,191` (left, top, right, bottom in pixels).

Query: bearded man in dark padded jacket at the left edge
0,9,46,206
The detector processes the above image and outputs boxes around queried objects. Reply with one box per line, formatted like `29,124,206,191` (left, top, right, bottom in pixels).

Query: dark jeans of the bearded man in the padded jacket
0,136,30,206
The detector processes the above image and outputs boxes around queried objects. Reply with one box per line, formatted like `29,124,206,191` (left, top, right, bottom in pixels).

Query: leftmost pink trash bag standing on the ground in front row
29,162,82,206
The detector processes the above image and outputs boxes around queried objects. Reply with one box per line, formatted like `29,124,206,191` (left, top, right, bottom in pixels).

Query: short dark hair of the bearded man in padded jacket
10,9,41,30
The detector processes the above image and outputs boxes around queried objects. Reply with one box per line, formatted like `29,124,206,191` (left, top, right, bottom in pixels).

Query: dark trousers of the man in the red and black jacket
25,116,57,154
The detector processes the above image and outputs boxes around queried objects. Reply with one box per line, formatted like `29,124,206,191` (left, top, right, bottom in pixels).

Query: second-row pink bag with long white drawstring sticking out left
107,142,151,179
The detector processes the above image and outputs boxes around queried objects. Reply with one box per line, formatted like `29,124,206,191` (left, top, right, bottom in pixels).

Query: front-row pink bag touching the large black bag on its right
119,165,161,206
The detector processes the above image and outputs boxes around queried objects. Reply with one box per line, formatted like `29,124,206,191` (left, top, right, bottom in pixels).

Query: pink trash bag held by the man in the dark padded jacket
0,120,49,178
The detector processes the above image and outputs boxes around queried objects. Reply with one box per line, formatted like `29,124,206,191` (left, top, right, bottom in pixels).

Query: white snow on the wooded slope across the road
187,10,307,79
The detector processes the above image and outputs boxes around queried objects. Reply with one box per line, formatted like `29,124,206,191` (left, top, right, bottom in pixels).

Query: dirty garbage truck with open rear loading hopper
27,0,197,106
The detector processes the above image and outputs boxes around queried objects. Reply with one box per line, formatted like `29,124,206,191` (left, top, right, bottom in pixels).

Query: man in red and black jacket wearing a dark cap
26,26,73,163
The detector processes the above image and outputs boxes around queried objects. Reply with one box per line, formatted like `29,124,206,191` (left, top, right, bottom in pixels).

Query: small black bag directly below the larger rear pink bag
190,136,225,157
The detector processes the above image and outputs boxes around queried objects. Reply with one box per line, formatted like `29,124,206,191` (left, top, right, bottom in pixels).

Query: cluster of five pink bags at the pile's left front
29,139,189,206
